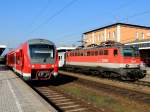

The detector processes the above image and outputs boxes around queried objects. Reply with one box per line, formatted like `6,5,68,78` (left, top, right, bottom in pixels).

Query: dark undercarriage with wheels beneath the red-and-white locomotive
62,65,146,81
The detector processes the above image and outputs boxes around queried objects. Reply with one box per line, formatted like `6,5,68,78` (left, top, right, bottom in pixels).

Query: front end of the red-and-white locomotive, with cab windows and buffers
120,47,146,80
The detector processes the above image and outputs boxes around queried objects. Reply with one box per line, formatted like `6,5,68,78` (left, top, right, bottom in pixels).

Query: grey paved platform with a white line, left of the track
0,66,57,112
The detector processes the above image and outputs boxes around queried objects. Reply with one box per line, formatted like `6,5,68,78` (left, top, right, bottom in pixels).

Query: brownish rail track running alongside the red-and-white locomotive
60,71,150,105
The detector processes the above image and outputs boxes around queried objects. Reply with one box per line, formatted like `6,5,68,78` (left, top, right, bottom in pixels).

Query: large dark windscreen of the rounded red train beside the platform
29,44,55,64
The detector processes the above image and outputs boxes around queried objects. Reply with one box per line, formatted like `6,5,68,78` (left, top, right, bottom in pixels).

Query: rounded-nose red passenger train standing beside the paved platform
6,39,58,80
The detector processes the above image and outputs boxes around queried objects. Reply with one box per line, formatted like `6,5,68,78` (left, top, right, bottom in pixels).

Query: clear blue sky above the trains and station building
0,0,150,47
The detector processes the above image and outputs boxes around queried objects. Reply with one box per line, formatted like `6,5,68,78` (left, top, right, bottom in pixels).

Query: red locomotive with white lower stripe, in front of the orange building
65,41,146,80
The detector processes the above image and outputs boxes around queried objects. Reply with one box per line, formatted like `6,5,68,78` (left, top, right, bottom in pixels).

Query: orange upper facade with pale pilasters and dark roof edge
83,23,150,46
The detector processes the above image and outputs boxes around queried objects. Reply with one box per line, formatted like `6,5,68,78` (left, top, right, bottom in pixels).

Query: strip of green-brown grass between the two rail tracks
57,85,146,112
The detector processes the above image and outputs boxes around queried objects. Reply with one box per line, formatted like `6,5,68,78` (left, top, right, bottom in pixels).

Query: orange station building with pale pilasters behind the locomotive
83,23,150,66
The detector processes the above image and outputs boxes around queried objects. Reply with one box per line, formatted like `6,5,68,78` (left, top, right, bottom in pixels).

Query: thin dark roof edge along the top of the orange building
83,23,150,34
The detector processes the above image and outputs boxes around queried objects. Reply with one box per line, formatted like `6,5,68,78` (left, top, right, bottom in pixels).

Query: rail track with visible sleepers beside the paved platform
29,80,101,112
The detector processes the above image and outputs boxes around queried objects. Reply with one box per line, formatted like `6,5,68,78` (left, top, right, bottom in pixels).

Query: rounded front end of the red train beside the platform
28,39,58,80
